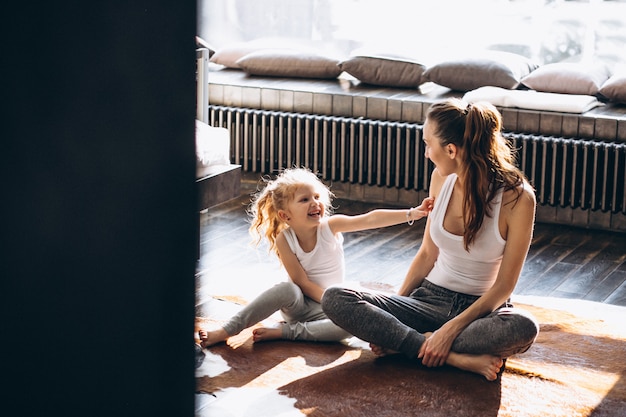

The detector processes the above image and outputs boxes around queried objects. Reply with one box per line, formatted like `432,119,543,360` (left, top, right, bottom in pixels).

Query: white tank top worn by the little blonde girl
284,217,345,288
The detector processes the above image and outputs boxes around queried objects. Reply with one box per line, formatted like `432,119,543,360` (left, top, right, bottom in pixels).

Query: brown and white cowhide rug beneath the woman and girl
197,297,626,417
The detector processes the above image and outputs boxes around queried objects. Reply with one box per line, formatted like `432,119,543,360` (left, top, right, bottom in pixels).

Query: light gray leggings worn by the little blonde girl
223,281,351,342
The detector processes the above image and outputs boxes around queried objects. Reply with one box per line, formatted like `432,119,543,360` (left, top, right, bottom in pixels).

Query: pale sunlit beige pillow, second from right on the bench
522,62,609,96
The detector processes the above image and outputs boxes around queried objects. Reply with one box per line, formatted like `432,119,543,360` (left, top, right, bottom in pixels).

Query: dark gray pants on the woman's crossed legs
322,280,539,358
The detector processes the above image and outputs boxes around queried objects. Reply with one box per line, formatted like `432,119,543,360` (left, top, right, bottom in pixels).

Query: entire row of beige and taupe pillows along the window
210,44,626,103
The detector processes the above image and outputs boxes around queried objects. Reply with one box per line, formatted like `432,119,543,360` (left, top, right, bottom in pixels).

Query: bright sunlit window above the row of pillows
198,0,626,70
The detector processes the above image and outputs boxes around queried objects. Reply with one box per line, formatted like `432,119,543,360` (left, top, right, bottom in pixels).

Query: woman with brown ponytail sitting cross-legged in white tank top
322,99,539,380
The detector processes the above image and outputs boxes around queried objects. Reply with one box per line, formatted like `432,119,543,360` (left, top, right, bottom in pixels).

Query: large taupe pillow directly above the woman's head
424,51,537,91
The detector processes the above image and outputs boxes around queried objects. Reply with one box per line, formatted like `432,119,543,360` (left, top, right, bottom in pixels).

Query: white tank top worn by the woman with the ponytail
426,174,506,296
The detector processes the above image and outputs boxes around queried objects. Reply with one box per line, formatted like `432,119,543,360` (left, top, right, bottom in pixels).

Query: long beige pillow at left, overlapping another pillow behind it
236,49,341,78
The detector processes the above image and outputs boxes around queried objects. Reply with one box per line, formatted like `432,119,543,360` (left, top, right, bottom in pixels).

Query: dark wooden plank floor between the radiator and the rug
196,190,626,315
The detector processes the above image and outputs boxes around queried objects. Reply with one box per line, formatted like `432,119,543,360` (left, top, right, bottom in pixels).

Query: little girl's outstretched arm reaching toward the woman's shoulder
328,197,434,233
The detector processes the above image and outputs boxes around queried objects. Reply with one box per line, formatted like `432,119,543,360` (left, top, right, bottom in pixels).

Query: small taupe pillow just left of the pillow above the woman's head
339,54,426,88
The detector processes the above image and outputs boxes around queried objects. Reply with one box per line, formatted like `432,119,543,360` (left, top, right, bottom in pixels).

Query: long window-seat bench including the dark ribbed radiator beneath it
209,69,626,232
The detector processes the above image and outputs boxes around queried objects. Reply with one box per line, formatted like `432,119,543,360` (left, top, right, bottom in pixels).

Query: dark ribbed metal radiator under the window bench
209,105,626,213
